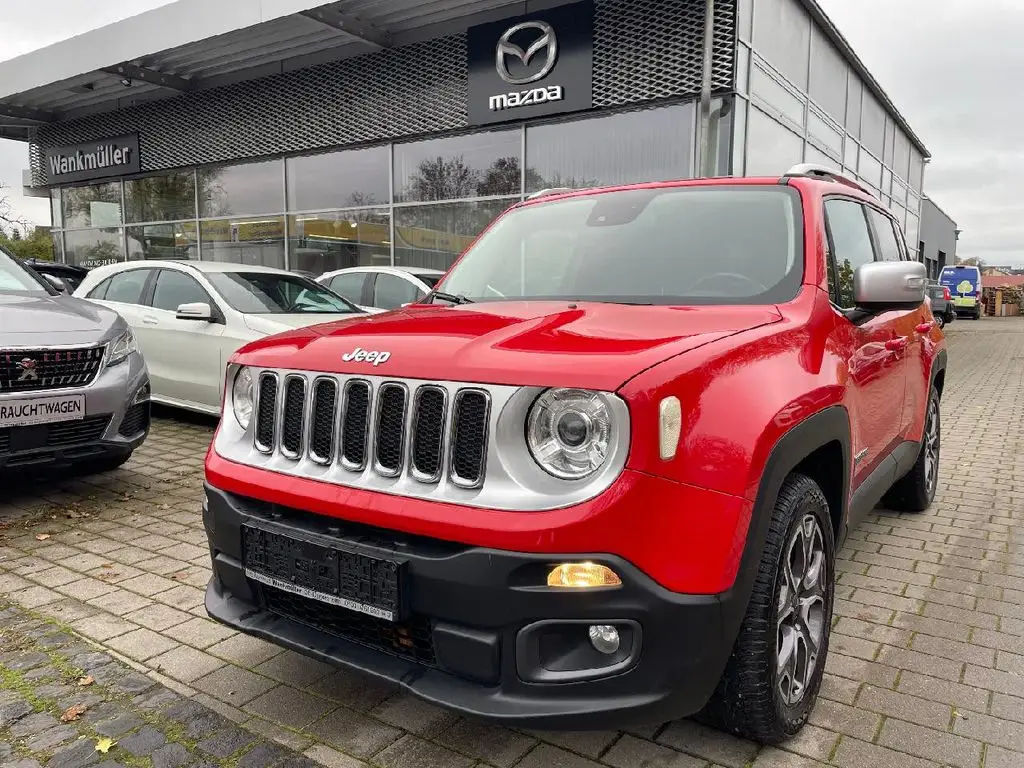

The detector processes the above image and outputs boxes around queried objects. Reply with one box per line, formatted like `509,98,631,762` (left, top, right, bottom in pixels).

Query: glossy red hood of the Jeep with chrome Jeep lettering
234,301,781,391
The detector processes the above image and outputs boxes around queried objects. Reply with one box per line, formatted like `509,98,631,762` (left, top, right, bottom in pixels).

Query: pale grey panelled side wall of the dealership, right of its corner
733,0,924,252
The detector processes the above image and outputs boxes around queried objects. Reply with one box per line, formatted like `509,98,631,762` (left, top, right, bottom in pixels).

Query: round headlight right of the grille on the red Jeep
526,389,611,480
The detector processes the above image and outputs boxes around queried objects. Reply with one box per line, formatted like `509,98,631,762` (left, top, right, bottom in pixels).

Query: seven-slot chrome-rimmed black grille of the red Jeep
254,372,490,488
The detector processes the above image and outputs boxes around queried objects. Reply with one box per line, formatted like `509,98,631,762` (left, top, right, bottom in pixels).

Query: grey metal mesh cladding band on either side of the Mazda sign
30,0,735,184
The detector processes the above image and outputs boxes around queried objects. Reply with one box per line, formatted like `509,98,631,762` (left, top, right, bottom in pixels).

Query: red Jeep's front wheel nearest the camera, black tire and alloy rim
701,473,835,743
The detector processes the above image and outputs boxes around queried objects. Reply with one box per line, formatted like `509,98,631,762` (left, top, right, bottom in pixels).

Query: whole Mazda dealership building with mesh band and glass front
0,0,929,286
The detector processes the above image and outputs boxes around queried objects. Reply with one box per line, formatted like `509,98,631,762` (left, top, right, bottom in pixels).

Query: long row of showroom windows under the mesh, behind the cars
51,99,696,274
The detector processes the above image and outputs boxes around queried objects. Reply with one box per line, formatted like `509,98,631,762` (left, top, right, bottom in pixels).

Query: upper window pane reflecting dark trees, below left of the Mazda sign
394,131,522,203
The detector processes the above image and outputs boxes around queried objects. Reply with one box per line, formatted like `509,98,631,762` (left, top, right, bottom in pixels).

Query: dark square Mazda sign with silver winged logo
467,0,594,125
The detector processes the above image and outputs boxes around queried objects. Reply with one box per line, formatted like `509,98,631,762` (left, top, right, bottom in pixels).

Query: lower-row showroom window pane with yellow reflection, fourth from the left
288,209,391,274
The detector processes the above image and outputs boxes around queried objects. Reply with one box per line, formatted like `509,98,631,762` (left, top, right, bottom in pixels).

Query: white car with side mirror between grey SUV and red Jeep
75,261,366,415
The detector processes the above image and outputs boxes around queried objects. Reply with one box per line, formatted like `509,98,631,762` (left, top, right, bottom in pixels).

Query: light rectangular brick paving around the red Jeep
0,317,1024,768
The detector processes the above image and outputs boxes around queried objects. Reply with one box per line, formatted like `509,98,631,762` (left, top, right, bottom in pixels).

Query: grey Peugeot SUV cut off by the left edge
0,249,150,472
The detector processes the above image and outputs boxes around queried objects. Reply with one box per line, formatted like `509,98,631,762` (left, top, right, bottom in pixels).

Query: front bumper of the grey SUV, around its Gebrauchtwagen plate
0,353,150,471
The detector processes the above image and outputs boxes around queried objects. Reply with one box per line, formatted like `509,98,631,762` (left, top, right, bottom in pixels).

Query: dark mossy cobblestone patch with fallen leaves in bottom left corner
0,599,316,768
